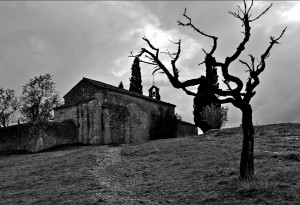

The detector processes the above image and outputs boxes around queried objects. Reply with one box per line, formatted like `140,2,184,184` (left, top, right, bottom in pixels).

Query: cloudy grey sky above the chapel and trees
0,1,300,130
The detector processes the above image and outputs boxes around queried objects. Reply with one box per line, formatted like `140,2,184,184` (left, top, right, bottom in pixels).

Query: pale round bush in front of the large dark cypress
200,104,228,129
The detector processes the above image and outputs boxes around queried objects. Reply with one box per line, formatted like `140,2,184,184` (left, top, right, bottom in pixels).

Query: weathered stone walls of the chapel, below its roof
54,90,175,144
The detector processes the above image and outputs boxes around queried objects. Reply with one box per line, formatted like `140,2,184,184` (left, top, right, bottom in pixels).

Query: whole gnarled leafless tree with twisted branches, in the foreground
131,0,286,180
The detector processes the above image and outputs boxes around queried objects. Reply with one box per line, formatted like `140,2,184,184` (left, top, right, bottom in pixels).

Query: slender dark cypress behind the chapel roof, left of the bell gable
129,57,143,94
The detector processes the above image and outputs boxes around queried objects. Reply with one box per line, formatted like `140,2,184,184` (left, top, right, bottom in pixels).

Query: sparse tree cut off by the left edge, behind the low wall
0,88,19,127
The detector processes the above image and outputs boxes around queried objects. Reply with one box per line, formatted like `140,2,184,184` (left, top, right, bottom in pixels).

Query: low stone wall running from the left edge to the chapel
0,121,78,152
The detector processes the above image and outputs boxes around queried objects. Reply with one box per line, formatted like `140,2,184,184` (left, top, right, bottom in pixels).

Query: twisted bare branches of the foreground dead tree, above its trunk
131,0,286,113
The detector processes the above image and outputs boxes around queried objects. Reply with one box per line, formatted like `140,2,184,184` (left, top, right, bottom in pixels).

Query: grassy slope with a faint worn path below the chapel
0,124,300,204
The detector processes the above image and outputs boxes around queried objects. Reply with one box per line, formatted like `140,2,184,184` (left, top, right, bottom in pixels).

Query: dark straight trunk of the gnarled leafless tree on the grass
240,104,254,180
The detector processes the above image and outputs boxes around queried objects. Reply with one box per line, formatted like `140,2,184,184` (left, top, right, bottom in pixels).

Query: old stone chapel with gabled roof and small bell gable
54,78,197,144
